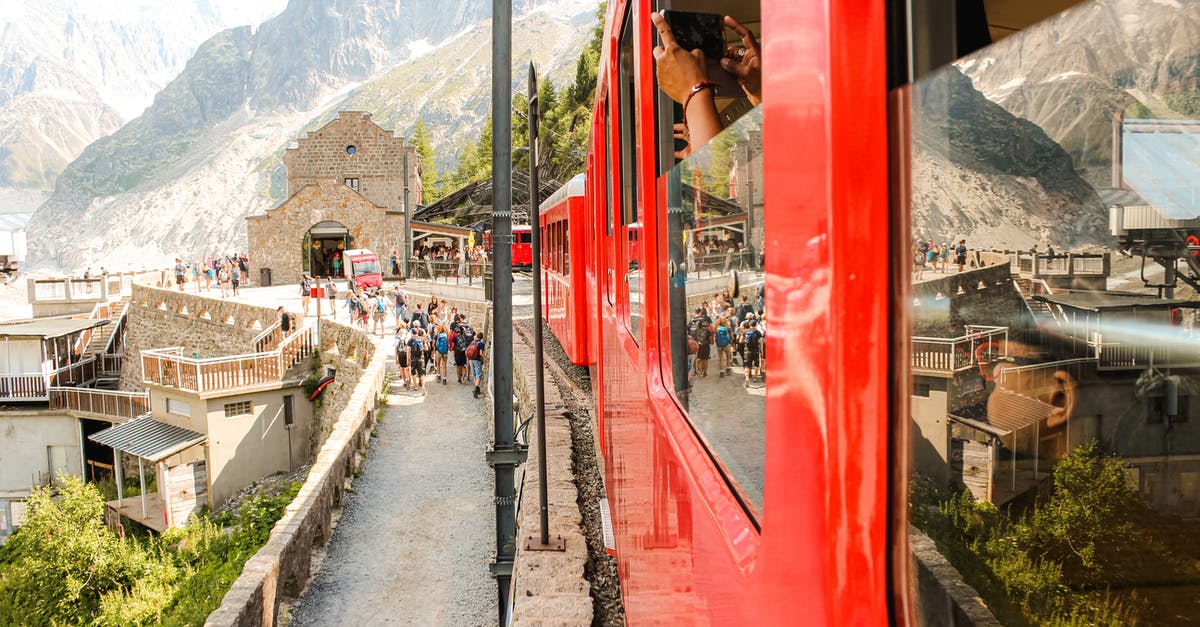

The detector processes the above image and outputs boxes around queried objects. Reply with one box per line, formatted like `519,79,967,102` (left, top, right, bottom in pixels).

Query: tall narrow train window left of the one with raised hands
617,8,642,342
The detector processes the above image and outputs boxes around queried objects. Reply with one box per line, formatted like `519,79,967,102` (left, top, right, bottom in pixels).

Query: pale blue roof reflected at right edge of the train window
1121,120,1200,220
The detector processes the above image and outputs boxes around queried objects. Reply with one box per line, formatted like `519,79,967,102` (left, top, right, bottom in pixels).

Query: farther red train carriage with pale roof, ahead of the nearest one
539,174,589,365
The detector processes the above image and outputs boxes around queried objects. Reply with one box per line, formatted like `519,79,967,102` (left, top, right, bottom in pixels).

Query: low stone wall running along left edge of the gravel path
205,323,391,627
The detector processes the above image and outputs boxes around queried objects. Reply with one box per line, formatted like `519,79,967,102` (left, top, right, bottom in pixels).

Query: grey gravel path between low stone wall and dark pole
287,366,497,626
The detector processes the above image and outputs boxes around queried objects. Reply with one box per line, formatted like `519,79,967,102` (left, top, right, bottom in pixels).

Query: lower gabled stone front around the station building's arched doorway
246,179,404,285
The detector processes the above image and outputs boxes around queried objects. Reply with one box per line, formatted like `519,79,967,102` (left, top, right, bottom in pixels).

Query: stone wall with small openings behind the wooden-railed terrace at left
120,280,292,390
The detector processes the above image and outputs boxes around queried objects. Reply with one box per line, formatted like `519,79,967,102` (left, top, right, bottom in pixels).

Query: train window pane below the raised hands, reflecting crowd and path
662,107,770,516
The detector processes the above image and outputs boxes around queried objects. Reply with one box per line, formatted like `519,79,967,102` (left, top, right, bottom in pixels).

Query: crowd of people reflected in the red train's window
688,285,767,390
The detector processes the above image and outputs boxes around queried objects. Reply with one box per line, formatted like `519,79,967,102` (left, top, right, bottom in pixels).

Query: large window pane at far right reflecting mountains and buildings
893,2,1200,625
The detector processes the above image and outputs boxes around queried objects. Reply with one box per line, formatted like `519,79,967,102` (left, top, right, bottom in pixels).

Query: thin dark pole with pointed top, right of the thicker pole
529,62,550,545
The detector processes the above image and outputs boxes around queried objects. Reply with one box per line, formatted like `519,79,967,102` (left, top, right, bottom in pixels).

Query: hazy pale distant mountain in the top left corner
0,0,283,211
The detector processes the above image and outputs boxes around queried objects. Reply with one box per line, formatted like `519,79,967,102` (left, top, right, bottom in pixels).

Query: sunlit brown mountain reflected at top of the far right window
958,0,1200,186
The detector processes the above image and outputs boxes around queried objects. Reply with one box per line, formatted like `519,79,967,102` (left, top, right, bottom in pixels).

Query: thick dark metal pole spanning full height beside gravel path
488,0,523,625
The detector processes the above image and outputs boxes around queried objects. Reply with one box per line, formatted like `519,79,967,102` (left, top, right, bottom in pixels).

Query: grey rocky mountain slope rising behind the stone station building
29,0,596,270
